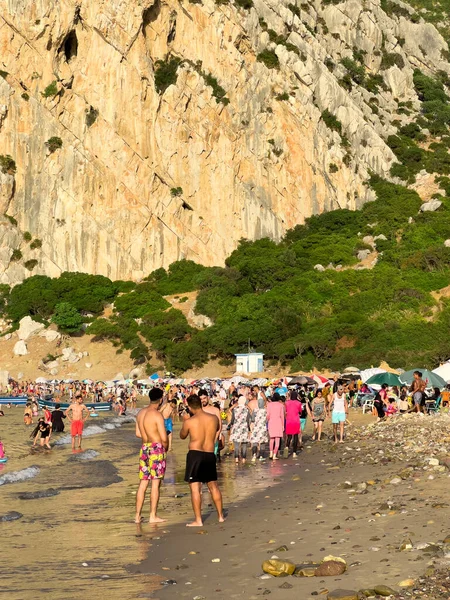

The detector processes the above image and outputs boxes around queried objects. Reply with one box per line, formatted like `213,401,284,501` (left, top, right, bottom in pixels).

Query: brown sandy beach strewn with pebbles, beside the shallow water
134,412,450,600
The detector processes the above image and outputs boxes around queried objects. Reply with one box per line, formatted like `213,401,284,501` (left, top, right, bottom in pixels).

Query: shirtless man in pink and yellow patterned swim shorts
135,388,169,523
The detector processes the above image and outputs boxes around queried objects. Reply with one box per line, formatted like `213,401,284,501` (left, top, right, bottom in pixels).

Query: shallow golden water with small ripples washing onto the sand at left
0,408,292,600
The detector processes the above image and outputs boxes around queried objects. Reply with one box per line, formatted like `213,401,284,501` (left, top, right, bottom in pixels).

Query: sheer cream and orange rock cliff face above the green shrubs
0,0,449,282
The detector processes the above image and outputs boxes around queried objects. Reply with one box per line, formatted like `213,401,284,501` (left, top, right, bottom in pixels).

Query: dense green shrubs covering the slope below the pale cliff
0,177,450,373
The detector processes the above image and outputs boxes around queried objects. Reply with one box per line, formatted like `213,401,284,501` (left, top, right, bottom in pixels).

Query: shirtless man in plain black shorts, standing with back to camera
180,395,225,527
